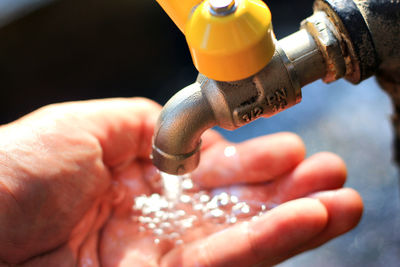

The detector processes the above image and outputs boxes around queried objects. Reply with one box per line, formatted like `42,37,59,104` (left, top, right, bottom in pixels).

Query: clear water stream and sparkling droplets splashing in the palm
133,172,271,245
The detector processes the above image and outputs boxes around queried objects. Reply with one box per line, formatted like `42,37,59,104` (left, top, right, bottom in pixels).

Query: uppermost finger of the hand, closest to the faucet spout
193,133,305,187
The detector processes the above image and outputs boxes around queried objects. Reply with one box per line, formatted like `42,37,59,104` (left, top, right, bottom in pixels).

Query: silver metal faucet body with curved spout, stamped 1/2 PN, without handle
152,30,325,174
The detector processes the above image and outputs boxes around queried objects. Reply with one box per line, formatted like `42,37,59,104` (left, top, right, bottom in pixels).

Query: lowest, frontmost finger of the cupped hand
161,199,328,267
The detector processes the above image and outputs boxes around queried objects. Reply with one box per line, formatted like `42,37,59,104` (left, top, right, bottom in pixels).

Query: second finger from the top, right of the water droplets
209,152,346,207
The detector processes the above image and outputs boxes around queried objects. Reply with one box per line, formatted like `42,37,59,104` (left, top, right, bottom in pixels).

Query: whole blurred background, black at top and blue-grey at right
0,0,400,267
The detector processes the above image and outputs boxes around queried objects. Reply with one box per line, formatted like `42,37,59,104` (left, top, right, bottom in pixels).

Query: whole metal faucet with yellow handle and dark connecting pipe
152,0,400,175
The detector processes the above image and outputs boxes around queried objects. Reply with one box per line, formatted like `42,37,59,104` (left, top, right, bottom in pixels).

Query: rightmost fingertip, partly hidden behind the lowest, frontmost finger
296,188,363,254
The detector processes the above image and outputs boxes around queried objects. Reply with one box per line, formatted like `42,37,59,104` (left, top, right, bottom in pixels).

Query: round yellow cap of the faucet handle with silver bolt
185,0,275,81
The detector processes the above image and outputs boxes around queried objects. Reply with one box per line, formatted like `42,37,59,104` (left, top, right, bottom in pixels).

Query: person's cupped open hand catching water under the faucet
0,98,363,267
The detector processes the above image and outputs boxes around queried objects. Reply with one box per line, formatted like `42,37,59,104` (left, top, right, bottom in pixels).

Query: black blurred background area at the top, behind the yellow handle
0,0,312,123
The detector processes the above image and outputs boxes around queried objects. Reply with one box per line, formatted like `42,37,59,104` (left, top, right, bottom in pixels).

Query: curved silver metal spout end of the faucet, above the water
152,83,216,175
